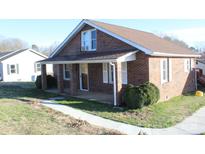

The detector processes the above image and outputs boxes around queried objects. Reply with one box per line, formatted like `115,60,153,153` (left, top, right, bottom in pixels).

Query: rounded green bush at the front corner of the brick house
124,82,160,109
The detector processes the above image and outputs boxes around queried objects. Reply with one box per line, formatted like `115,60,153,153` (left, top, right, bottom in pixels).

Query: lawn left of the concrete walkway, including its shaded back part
0,83,120,135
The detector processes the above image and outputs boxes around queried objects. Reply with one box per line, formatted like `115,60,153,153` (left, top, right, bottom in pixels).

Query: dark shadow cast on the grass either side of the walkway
0,82,126,113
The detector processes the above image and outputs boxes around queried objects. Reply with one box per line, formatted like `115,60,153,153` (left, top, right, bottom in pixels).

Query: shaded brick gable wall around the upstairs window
59,25,135,56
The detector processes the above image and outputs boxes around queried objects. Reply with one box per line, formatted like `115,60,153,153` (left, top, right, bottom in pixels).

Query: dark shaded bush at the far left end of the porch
35,75,57,89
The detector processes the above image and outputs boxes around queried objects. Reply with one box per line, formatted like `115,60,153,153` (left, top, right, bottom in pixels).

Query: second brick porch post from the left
57,64,64,93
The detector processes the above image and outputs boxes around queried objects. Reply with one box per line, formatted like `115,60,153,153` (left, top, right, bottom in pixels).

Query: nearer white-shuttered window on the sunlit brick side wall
161,58,172,84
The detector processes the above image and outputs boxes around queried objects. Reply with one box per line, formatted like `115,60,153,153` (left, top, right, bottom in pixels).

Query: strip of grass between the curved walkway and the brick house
58,91,205,128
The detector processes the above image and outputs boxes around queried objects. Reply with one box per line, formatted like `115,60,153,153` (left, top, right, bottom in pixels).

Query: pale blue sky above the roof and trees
0,19,205,47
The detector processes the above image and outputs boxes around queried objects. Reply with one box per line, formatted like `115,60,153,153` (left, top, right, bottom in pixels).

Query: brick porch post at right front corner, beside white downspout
115,62,122,106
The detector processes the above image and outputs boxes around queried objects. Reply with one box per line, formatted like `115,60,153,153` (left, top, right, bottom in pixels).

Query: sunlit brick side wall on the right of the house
149,57,195,100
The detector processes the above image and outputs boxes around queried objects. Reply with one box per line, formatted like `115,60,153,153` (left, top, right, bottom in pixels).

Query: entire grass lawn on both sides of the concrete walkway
0,83,205,130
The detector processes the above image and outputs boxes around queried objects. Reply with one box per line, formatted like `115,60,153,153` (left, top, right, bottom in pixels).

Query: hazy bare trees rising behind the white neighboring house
0,38,28,52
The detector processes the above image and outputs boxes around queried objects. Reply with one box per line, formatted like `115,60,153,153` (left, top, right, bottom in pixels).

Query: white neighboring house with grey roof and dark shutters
0,49,53,82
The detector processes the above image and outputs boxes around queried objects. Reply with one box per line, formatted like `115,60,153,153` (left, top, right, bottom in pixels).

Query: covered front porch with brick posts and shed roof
40,52,136,106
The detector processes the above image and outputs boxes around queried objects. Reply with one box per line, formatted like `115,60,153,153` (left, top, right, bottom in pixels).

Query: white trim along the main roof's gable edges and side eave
49,19,199,57
